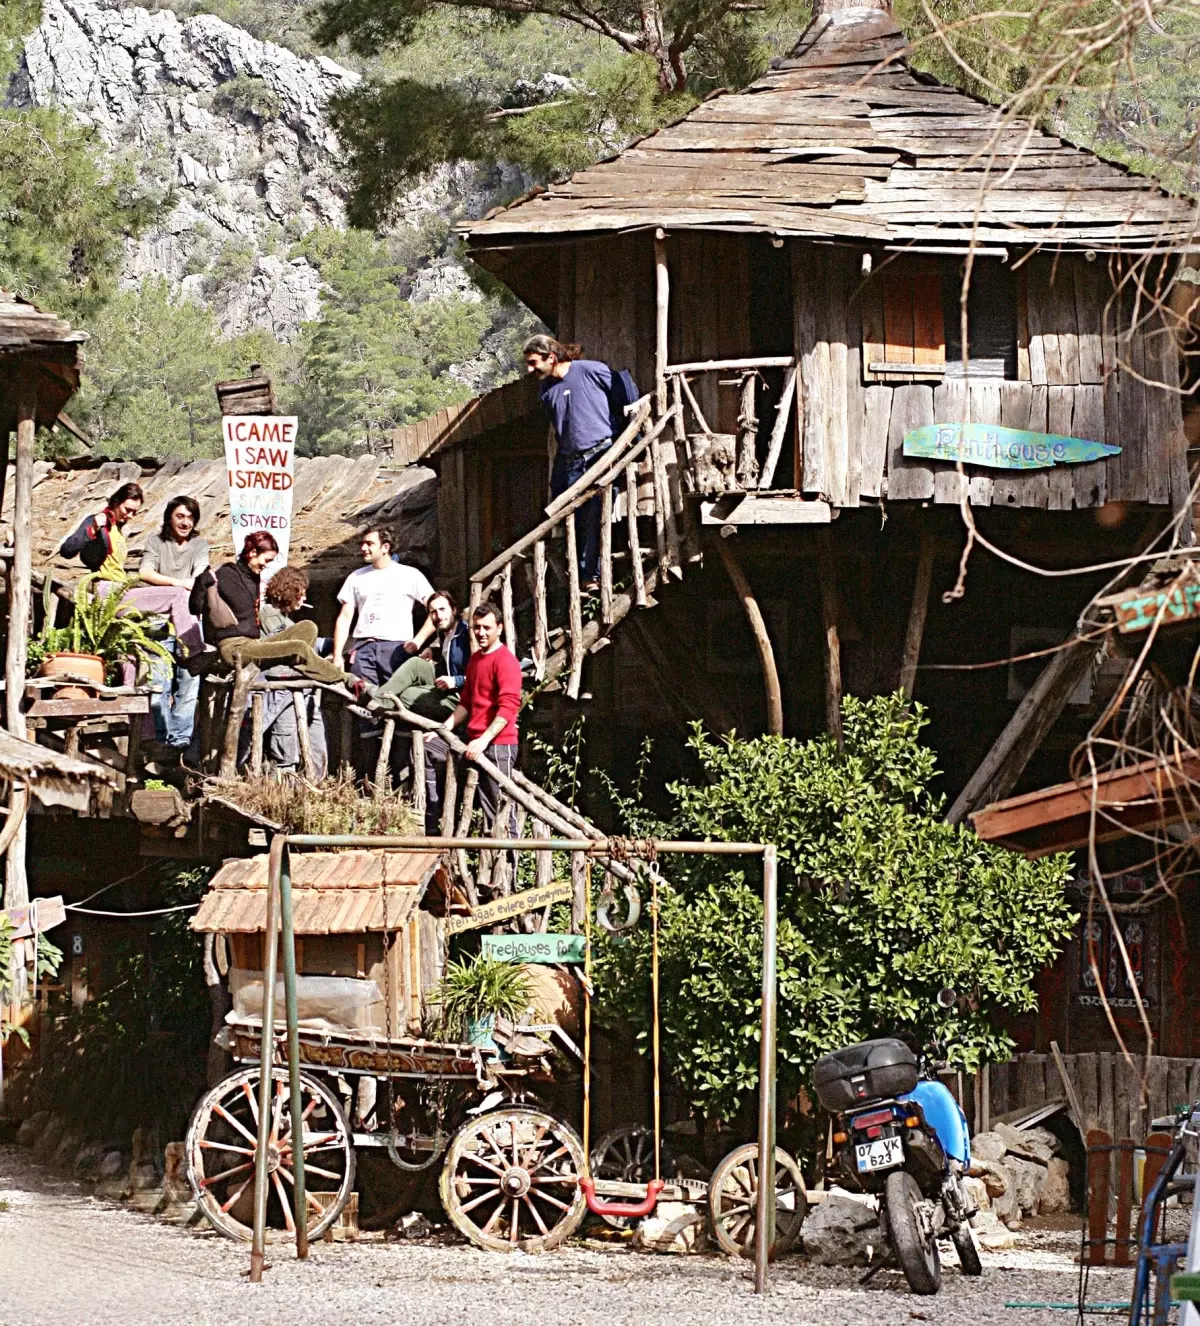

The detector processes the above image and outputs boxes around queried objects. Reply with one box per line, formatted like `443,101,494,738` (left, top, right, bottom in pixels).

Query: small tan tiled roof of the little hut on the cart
191,851,442,935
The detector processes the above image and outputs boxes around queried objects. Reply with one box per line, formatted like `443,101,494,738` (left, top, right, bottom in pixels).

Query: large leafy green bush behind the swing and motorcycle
598,695,1074,1116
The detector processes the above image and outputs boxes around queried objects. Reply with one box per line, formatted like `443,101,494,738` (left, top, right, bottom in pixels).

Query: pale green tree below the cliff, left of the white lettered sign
72,277,286,459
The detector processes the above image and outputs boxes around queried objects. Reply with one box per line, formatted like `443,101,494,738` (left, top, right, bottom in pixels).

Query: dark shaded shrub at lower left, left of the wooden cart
15,865,212,1140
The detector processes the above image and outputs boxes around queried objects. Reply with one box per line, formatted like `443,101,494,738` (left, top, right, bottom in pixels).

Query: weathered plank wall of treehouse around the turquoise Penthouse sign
784,243,1187,511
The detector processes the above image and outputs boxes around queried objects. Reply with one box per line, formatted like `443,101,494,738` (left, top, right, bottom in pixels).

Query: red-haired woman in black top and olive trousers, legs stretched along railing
188,529,355,688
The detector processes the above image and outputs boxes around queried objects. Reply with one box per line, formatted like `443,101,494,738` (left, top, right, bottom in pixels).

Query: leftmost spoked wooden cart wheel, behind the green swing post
187,1067,354,1241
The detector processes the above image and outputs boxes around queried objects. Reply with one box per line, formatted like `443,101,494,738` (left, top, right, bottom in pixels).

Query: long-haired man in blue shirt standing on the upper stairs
524,335,638,594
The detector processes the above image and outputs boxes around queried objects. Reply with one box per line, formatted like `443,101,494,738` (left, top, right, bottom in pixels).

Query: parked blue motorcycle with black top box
813,998,984,1294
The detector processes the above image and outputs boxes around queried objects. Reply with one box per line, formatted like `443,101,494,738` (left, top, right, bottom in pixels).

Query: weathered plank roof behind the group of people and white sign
16,456,438,578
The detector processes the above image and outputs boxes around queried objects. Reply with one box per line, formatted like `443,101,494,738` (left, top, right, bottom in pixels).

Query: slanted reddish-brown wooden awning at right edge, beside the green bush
971,756,1200,858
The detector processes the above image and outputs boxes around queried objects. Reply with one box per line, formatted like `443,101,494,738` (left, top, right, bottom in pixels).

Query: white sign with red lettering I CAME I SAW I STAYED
221,415,297,572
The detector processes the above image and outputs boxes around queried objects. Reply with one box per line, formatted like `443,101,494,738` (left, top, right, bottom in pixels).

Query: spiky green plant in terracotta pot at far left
29,575,171,695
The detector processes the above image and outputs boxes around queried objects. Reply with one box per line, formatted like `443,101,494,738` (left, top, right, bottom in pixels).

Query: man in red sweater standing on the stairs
426,602,521,834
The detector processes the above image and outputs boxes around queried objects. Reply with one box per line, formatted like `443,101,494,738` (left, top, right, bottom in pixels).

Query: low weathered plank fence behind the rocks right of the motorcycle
989,1054,1200,1143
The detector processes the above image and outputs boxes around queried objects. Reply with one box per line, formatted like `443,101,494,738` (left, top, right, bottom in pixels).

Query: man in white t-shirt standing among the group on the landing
333,525,434,716
